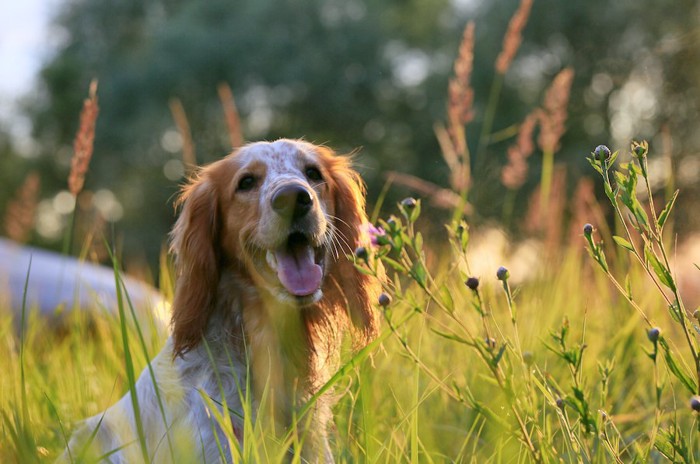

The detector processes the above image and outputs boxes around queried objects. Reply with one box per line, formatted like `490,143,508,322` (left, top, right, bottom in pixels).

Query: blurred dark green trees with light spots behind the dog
0,0,700,272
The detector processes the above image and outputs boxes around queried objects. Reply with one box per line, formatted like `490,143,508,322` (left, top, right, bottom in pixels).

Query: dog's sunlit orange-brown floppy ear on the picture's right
321,148,383,342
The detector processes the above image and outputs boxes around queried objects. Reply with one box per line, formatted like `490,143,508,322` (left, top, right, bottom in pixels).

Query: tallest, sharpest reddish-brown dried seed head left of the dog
68,79,100,197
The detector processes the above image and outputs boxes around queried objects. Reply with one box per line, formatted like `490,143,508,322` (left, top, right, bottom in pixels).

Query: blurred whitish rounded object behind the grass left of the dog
0,238,170,334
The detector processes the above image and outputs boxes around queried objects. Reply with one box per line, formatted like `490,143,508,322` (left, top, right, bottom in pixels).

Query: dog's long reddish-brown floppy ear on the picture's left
171,172,219,355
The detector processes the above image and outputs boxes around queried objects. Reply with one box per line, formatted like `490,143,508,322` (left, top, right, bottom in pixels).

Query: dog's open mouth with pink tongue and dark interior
266,232,323,297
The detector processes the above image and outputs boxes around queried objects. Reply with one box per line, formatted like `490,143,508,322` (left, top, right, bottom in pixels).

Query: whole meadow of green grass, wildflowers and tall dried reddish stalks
0,2,700,463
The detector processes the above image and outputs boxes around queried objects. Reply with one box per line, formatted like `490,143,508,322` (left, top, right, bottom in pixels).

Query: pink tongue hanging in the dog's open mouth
275,245,323,296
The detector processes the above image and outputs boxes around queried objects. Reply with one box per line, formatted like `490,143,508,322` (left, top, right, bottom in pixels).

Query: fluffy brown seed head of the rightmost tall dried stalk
537,68,574,153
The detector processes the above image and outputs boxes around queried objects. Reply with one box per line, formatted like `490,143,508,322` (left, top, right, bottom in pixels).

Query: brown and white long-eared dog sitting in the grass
64,139,381,463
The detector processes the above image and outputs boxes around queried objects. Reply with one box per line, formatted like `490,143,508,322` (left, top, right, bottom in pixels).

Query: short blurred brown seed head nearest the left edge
5,171,41,243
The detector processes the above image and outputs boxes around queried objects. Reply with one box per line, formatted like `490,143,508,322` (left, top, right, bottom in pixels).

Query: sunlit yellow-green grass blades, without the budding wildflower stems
0,224,698,463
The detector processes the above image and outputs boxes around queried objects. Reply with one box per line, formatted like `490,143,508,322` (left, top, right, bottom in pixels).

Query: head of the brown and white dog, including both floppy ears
172,140,378,353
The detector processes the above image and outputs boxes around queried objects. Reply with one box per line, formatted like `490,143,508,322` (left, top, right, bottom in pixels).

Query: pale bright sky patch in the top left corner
0,0,57,144
